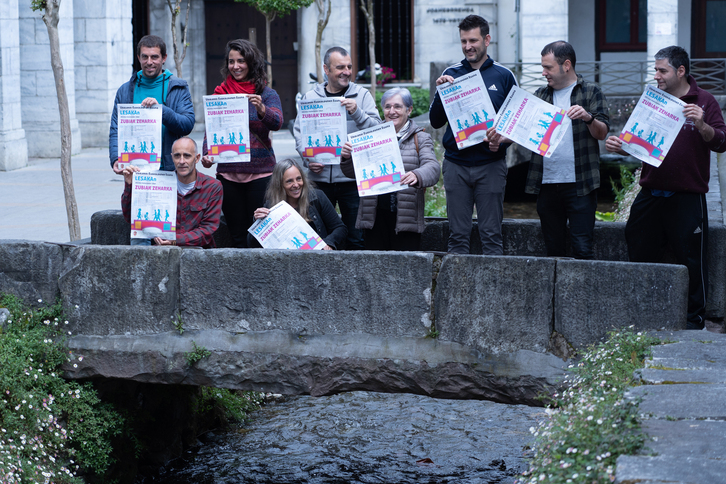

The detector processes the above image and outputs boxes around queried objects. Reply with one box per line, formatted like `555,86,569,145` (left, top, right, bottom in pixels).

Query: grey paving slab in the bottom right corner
615,455,726,484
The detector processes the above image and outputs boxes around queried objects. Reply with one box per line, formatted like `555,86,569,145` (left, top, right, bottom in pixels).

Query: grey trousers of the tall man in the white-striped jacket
443,158,507,255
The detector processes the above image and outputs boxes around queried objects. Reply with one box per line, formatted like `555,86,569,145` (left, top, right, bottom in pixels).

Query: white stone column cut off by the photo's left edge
0,2,28,171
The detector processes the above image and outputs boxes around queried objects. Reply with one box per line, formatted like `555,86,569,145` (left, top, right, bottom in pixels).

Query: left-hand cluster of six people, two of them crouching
114,35,440,250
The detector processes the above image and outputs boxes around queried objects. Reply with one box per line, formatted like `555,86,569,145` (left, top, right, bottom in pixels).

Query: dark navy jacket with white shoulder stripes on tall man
429,56,517,166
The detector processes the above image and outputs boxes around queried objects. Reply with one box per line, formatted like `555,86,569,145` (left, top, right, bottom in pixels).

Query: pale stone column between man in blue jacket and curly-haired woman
149,0,205,131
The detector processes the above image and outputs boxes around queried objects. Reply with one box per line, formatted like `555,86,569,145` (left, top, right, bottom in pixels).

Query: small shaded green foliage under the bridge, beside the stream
192,387,264,423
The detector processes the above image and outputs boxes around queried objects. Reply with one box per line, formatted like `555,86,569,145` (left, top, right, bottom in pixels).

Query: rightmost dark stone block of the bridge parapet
554,260,688,349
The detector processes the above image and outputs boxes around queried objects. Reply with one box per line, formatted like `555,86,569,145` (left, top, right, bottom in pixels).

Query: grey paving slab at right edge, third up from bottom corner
625,383,726,420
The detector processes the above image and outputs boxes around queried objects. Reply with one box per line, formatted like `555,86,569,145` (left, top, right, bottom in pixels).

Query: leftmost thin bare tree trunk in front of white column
43,0,81,241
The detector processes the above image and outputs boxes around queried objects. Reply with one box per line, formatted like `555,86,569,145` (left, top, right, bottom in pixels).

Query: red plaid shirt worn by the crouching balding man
121,172,222,249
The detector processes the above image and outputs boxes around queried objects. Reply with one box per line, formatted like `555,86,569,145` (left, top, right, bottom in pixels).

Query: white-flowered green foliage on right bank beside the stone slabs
516,326,660,484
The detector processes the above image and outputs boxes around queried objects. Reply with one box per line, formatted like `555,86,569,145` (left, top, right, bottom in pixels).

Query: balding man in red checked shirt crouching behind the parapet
121,136,222,249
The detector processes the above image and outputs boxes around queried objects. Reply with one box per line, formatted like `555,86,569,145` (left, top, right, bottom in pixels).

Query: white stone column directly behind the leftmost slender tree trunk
19,0,81,158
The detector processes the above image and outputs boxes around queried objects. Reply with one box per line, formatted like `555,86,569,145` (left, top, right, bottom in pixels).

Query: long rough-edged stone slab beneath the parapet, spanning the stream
64,329,566,405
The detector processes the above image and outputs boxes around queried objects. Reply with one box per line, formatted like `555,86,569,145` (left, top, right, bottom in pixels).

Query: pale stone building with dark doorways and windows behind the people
0,0,726,170
